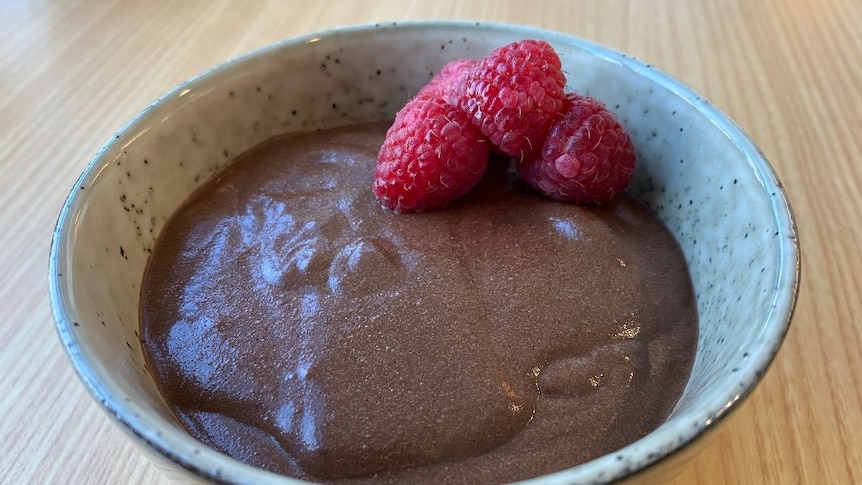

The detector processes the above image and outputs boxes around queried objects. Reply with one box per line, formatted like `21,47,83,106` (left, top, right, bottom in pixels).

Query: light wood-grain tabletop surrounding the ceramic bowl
0,0,862,484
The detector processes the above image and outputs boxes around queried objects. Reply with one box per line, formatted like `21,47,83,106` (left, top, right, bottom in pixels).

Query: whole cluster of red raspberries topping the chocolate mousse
373,40,635,212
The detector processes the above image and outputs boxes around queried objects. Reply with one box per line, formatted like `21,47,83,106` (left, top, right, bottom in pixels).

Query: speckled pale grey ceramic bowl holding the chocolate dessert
49,22,799,485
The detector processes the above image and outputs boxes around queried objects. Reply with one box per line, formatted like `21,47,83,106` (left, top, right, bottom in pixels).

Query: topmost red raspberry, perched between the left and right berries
456,39,566,160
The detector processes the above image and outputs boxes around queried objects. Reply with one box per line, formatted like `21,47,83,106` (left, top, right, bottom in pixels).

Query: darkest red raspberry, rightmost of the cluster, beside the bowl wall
517,93,635,204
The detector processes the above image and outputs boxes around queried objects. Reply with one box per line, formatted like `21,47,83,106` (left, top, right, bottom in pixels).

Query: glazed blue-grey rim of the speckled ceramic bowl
48,19,801,485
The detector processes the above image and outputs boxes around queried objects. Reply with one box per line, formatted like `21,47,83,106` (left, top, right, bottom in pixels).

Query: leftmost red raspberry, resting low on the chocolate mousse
374,96,488,212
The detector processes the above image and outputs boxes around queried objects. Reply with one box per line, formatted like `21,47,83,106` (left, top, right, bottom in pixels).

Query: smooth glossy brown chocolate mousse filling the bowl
141,124,697,483
